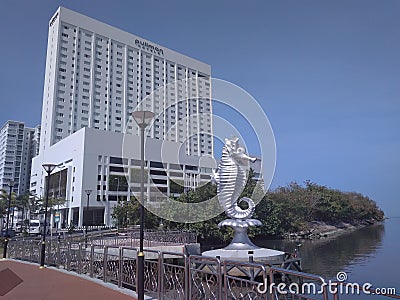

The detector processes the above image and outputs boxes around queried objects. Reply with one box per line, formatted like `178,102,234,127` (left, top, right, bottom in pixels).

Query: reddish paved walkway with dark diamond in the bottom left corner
0,260,135,300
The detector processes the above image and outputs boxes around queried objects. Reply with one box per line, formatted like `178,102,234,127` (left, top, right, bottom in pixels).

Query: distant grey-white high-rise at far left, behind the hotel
0,121,40,195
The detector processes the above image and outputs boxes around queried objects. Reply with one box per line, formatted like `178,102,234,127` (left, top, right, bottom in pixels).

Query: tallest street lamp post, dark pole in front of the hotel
132,111,154,300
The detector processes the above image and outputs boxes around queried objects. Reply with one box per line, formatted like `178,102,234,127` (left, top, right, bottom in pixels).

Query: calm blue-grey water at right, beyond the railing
257,217,400,299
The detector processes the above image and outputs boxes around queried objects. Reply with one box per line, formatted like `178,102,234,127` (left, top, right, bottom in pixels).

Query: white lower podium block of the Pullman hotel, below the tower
31,127,216,226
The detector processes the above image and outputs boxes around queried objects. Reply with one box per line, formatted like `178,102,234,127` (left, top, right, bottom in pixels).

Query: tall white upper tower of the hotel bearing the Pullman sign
40,7,213,155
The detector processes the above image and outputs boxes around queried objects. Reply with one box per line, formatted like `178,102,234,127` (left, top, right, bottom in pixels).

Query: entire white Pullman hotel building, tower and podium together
31,7,213,226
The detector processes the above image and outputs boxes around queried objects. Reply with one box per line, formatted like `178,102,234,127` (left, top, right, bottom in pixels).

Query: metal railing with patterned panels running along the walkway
9,240,400,300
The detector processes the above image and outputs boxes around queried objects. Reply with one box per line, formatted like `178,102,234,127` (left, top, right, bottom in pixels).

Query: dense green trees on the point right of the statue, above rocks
269,181,384,233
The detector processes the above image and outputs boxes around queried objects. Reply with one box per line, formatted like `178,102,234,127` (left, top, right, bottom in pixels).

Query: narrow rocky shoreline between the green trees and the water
284,219,378,240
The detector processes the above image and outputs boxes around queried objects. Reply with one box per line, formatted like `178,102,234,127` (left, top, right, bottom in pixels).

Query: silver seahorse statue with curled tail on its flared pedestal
213,137,261,250
